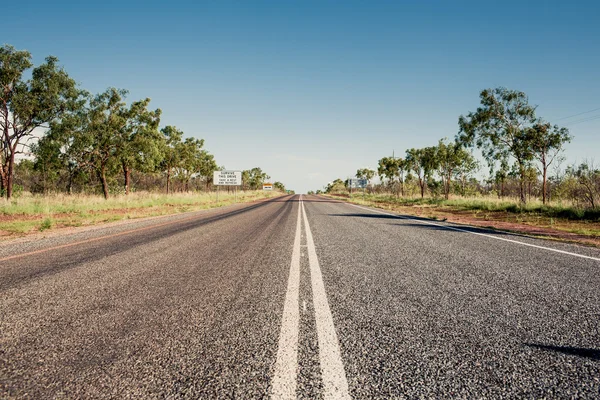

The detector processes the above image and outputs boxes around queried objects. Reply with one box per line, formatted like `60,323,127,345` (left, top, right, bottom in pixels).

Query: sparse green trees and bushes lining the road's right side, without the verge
318,88,600,219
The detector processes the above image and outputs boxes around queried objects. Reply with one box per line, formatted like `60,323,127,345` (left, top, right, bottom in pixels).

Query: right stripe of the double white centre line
300,201,350,399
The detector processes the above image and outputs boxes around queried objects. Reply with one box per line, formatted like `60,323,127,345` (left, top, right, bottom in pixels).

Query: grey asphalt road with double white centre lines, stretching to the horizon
0,195,600,399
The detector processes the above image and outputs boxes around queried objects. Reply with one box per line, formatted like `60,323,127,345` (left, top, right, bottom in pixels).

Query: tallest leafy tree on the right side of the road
457,88,536,203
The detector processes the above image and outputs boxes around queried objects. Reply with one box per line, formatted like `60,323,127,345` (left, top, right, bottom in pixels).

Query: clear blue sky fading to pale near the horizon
0,0,600,193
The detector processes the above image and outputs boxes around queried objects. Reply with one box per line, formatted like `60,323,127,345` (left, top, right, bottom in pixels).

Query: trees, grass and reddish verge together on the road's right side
316,88,600,244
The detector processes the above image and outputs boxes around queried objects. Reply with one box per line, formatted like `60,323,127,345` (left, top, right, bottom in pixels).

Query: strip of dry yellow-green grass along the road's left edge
0,191,281,237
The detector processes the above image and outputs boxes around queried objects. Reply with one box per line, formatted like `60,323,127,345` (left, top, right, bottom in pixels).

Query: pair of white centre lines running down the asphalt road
271,196,350,399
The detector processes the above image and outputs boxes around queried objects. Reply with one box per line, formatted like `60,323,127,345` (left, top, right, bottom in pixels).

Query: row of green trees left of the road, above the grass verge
0,45,285,201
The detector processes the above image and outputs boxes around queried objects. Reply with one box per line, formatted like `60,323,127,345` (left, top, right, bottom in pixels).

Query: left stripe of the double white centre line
271,195,302,399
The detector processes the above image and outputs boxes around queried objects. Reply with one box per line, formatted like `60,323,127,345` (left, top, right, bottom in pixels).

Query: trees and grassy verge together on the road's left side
0,45,286,236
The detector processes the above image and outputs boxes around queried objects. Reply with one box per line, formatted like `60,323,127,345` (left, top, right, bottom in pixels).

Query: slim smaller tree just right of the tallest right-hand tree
527,121,572,204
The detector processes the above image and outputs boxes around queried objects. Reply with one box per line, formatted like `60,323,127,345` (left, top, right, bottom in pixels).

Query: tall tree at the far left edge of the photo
0,45,81,199
